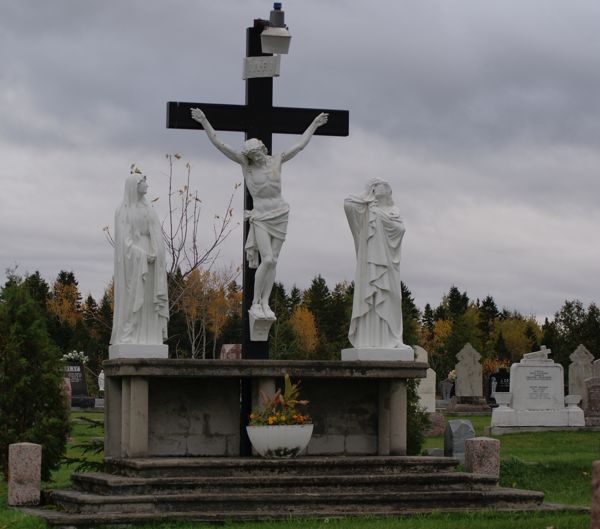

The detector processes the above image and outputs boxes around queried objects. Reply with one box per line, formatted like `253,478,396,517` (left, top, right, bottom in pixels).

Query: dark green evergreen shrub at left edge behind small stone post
0,277,69,480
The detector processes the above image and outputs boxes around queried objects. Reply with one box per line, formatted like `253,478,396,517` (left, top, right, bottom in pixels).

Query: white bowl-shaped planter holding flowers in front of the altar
246,424,313,457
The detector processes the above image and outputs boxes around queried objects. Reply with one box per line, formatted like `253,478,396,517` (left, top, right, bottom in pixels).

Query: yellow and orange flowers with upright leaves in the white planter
249,373,312,426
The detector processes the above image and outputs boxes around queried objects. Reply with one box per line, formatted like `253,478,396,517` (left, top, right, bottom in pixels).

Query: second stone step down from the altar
71,472,498,495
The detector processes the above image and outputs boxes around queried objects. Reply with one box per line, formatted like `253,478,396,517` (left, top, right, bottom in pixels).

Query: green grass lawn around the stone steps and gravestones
0,413,600,529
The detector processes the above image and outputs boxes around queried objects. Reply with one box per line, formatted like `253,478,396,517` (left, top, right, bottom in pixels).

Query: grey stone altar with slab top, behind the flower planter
104,358,428,458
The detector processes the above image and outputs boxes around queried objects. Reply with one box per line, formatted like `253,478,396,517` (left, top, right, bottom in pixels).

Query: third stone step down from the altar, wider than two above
50,487,544,516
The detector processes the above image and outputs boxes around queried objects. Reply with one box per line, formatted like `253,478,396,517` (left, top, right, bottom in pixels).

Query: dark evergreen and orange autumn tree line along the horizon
4,267,600,378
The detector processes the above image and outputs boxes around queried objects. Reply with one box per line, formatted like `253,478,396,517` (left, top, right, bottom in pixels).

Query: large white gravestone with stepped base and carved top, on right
491,346,585,434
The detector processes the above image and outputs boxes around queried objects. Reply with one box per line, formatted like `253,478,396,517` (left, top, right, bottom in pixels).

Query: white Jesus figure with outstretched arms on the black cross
191,108,328,336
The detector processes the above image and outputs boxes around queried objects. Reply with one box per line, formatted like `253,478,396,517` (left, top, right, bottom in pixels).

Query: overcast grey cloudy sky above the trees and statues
0,0,600,317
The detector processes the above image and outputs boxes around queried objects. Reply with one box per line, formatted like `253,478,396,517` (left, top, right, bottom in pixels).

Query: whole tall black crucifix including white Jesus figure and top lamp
167,4,349,359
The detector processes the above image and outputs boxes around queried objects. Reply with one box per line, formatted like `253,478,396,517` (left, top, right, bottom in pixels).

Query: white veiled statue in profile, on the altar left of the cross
109,173,169,358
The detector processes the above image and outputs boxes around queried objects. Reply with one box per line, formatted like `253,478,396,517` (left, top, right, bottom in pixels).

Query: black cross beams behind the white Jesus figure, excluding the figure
167,19,349,359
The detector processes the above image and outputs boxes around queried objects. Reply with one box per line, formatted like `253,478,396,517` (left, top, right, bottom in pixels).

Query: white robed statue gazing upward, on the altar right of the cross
342,179,414,360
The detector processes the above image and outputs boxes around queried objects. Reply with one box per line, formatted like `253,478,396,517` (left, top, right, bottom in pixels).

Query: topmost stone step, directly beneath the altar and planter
104,456,458,478
